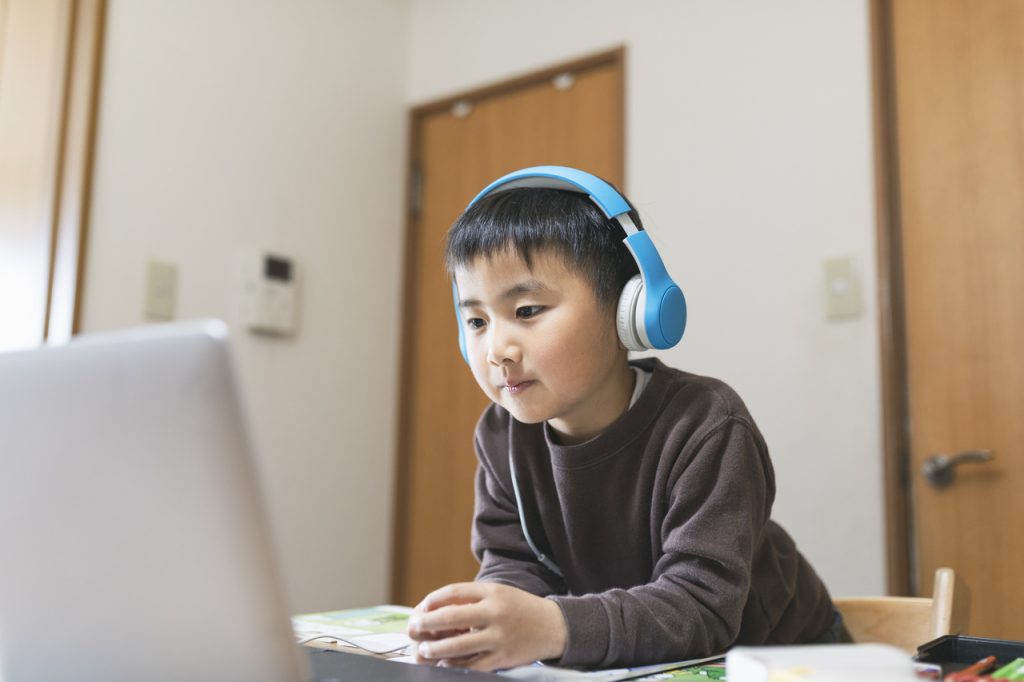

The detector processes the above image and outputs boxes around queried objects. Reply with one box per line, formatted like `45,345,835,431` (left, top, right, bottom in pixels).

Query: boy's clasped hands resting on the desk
409,583,567,671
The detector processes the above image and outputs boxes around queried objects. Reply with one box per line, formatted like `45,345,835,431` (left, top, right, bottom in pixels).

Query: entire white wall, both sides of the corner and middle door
84,0,884,611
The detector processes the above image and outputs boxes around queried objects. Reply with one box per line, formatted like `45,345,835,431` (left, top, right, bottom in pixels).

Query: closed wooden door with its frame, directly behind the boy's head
392,50,623,604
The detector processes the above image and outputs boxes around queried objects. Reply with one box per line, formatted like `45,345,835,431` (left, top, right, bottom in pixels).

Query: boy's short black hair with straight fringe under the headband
444,187,642,306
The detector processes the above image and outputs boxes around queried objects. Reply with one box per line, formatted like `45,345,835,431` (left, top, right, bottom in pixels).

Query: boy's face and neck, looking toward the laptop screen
455,246,634,443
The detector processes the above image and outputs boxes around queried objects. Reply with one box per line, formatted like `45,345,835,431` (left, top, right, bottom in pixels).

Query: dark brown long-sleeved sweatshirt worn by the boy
472,358,834,667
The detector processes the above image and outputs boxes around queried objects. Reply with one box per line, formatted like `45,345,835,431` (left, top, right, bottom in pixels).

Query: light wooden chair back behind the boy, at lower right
834,568,969,653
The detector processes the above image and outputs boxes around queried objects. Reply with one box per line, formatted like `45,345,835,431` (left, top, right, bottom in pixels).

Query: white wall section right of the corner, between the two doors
407,0,885,594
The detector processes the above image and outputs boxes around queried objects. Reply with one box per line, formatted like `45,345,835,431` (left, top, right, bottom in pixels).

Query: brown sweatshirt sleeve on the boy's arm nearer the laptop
471,420,565,597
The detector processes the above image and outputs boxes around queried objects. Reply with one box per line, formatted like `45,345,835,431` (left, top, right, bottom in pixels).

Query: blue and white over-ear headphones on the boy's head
452,166,686,364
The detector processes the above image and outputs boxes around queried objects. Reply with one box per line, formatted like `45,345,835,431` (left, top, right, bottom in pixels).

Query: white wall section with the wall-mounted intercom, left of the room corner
84,0,408,611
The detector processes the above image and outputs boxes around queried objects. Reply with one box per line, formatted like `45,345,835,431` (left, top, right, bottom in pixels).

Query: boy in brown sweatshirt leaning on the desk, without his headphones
409,171,841,670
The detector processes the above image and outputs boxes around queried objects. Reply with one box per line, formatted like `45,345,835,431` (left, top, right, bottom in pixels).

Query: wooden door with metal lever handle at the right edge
891,0,1024,639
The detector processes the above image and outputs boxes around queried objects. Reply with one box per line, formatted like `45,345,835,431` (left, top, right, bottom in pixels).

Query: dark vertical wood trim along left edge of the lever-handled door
869,0,915,595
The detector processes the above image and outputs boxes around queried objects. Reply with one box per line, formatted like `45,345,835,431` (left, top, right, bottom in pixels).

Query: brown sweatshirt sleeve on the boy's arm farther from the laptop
550,417,772,668
